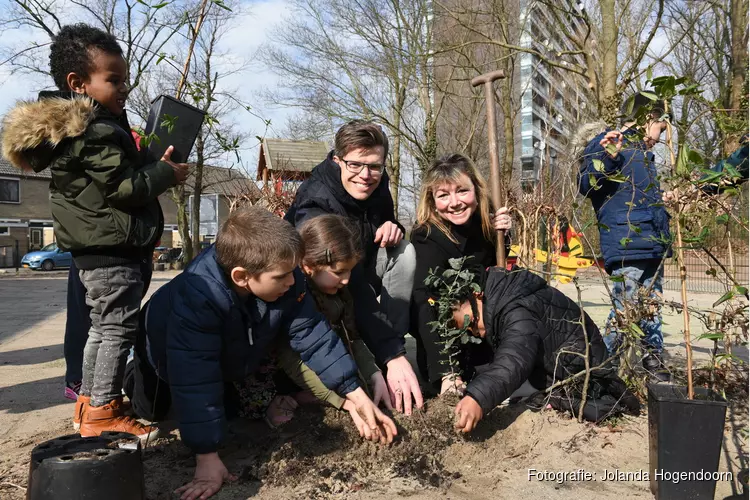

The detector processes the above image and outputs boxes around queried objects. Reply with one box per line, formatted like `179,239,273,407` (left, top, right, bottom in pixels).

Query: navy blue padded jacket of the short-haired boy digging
144,245,359,453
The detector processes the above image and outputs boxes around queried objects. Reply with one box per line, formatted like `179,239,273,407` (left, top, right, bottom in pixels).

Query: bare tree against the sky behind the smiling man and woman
262,0,442,215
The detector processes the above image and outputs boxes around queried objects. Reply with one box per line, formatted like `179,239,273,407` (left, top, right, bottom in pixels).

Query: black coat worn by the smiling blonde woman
409,214,497,387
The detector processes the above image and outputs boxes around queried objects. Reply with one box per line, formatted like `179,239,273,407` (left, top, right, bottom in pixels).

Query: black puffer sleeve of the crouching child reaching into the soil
466,307,543,413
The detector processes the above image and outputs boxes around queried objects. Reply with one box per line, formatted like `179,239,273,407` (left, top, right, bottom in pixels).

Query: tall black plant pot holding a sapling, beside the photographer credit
648,384,727,500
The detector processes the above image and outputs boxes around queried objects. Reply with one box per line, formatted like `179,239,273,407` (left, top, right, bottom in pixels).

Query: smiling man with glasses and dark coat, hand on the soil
285,120,422,415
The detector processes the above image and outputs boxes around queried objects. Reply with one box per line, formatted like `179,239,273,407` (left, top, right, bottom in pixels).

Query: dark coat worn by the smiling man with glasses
284,152,406,365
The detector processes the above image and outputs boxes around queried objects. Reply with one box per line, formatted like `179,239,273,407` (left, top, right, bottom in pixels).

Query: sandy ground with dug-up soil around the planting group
0,272,748,500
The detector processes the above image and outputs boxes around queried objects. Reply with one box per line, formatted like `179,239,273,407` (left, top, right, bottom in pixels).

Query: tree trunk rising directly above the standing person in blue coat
599,0,620,127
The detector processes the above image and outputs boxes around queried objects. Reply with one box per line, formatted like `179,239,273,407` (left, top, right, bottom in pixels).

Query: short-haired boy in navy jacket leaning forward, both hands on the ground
126,207,396,500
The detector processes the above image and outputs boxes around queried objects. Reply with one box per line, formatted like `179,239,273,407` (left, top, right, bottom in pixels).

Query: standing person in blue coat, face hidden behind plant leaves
578,93,671,380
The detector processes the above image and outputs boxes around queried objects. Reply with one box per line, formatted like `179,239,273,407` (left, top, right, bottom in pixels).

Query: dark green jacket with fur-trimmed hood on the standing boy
2,92,175,269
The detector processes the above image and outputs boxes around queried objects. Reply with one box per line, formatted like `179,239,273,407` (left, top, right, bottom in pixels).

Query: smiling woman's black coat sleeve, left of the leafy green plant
411,228,455,383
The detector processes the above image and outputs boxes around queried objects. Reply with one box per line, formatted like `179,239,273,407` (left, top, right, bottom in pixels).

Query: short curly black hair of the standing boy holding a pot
49,23,122,91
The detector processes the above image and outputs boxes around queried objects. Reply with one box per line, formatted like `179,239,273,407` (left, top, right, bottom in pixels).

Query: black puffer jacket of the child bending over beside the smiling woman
466,268,616,413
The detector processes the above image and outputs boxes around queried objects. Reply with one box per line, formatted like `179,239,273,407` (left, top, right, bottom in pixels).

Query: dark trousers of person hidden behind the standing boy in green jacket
63,253,153,384
